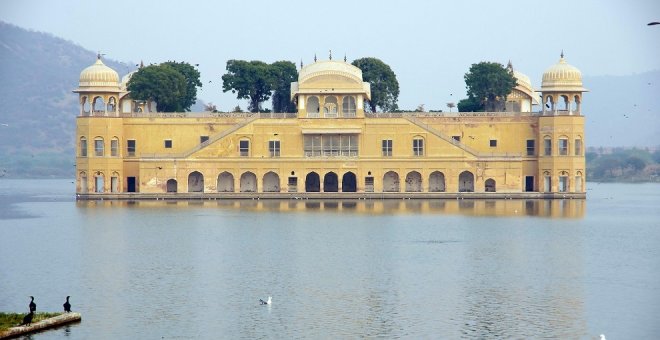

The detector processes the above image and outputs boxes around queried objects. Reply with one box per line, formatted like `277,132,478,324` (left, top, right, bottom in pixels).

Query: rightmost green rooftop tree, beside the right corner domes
464,61,516,111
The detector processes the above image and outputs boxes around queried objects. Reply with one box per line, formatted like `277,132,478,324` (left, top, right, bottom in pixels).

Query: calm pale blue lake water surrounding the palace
0,179,660,339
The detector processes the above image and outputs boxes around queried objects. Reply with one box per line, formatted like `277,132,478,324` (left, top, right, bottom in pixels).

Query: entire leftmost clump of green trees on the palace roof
126,62,202,112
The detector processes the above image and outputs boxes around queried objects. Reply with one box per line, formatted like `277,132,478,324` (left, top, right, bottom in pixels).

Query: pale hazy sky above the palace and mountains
0,0,660,110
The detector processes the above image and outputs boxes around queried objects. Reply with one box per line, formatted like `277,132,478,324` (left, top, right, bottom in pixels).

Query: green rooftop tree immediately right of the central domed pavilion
352,58,399,112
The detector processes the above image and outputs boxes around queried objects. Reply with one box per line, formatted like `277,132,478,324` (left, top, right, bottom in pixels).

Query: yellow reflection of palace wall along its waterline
77,199,586,218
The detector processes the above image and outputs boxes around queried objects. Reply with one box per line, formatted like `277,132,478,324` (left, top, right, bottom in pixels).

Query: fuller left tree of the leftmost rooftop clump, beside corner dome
127,65,188,112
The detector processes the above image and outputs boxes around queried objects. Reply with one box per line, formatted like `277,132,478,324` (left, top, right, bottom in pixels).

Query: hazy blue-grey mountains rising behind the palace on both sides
0,21,660,178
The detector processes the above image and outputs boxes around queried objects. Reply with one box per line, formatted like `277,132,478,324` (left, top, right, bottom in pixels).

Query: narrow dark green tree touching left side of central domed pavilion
270,61,298,112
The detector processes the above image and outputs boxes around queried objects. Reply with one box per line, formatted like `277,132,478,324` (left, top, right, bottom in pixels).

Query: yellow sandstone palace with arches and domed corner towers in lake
74,55,587,199
